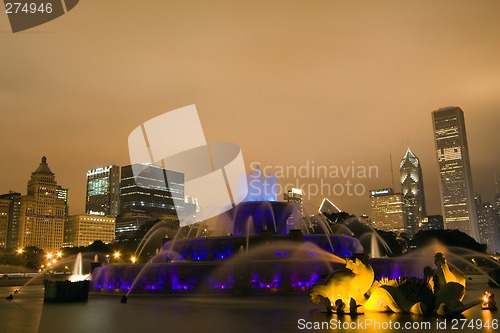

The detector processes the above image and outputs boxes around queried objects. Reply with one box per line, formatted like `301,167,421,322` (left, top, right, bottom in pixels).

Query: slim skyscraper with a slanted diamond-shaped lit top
399,148,427,235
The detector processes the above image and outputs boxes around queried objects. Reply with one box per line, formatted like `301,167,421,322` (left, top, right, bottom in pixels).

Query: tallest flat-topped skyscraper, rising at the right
432,107,480,241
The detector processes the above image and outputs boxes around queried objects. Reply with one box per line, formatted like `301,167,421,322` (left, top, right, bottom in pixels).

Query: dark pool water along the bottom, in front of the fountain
0,276,500,333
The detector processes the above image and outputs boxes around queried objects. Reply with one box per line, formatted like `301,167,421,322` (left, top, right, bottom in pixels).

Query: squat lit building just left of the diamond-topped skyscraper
370,188,406,233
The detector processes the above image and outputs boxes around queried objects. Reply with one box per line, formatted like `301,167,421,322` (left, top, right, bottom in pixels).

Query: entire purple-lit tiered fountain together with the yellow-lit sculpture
91,196,495,316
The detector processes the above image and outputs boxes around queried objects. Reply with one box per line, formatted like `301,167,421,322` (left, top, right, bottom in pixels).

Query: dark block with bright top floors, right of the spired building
85,165,120,217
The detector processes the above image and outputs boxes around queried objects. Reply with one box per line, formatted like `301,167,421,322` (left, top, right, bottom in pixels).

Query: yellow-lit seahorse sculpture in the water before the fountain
309,252,481,316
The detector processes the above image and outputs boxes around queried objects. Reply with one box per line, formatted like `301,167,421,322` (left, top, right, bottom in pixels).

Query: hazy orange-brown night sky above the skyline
0,0,500,214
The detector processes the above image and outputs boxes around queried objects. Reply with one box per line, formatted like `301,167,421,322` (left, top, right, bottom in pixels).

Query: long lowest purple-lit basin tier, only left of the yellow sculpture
92,260,348,294
